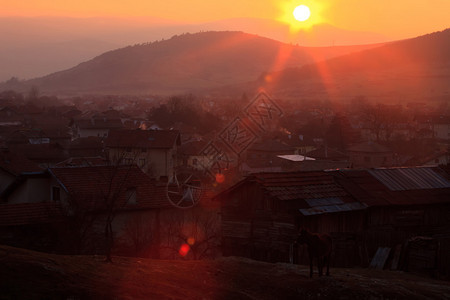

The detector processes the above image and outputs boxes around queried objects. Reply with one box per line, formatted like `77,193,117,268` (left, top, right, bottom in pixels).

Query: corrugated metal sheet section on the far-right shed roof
369,168,450,191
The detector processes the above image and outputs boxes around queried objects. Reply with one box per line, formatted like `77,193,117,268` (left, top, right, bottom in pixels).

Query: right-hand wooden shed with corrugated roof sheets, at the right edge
338,167,450,275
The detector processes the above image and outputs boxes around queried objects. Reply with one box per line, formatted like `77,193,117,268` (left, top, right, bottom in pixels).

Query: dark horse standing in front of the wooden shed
295,229,332,277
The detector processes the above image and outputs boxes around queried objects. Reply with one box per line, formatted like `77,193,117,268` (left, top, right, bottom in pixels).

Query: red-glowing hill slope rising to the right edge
256,29,450,103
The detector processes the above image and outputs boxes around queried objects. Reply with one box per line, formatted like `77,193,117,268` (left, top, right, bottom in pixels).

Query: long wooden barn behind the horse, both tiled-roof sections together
216,167,450,274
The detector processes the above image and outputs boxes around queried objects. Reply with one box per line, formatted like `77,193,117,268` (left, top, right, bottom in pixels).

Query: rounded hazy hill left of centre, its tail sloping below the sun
20,31,379,94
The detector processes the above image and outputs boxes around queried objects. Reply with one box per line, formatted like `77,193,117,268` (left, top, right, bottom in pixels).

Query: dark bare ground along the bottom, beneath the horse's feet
0,246,450,300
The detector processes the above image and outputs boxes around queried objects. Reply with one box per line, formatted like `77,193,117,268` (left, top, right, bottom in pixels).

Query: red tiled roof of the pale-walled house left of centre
106,130,181,148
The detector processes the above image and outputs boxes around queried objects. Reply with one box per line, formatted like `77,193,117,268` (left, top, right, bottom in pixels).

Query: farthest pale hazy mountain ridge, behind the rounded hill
0,16,388,81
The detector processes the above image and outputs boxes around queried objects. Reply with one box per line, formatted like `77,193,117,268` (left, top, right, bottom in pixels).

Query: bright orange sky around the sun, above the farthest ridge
0,0,450,39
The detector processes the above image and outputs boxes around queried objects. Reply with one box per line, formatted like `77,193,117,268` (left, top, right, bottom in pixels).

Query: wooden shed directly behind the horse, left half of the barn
217,171,366,265
